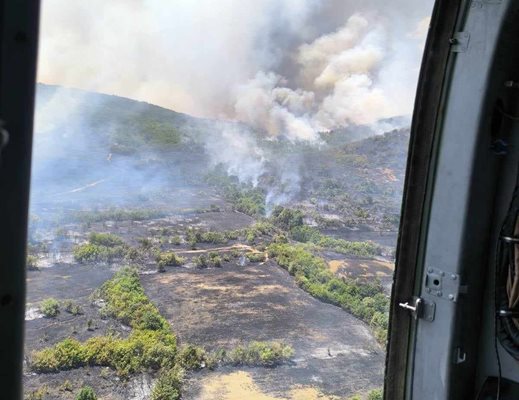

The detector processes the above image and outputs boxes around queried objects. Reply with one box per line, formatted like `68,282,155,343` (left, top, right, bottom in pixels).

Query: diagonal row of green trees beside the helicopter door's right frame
268,243,389,342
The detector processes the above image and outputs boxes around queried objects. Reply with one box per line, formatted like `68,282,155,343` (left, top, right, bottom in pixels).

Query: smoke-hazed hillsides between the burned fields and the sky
33,84,408,233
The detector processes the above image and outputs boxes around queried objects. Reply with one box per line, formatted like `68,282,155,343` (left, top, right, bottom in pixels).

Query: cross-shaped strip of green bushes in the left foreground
30,267,293,400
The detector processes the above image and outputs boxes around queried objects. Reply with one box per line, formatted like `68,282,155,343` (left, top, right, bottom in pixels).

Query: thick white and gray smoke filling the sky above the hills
38,0,433,205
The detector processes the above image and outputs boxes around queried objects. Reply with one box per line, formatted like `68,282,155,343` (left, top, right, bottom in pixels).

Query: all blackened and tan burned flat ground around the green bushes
24,193,390,400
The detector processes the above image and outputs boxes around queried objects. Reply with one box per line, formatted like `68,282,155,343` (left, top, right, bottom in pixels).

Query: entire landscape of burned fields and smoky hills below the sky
24,86,407,400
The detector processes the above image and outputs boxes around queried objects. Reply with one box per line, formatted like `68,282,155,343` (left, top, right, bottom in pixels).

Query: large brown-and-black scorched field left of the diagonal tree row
143,261,384,398
